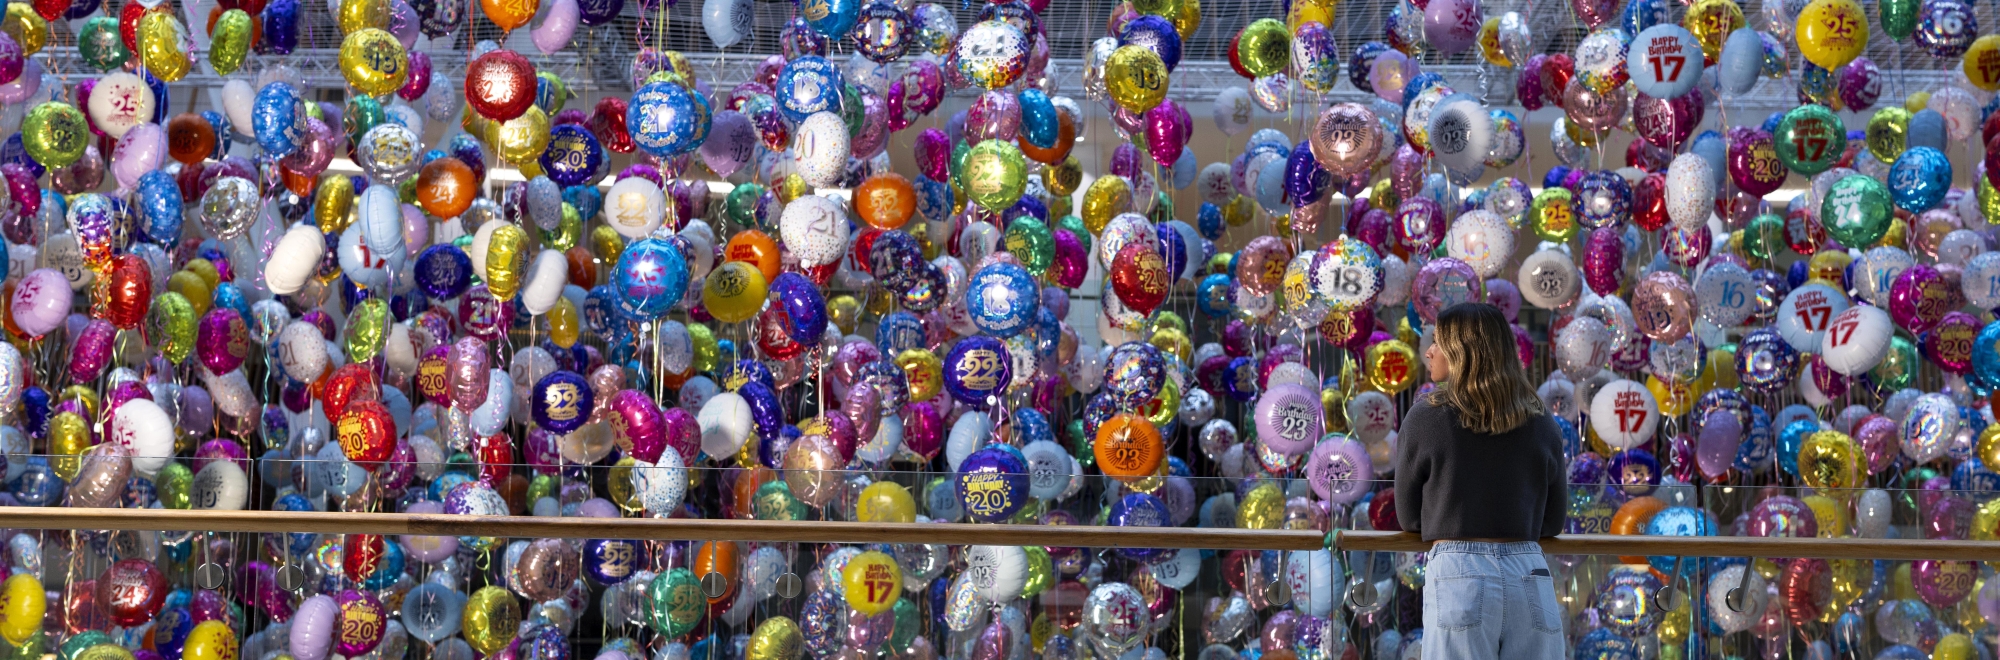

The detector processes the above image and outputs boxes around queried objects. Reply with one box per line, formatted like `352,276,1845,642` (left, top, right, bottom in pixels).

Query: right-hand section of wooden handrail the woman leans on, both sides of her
1334,530,2000,562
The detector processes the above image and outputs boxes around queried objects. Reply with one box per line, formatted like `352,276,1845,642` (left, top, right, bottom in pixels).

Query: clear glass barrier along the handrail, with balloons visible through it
0,446,2000,660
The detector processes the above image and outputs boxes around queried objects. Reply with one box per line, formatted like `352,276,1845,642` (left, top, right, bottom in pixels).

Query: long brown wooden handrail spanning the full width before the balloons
0,506,2000,562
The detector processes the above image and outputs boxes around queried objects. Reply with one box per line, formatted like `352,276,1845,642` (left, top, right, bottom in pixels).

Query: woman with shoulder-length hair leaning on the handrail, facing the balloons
1396,302,1568,660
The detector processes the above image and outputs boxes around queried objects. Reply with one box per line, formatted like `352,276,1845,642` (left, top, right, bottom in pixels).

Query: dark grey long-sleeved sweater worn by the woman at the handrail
1396,398,1570,540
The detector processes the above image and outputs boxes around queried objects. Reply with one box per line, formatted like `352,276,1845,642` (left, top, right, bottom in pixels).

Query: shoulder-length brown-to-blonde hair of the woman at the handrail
1428,302,1542,434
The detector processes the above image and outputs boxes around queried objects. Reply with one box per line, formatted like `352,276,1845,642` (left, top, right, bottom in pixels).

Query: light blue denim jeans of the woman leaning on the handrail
1424,540,1566,660
